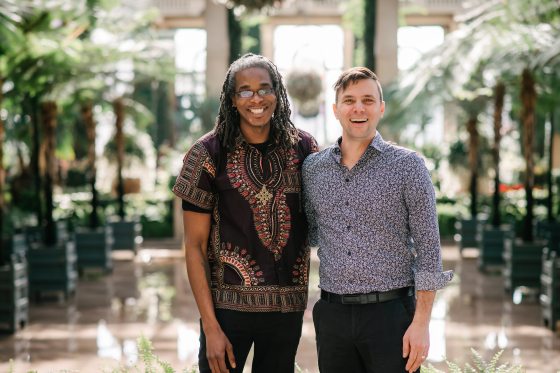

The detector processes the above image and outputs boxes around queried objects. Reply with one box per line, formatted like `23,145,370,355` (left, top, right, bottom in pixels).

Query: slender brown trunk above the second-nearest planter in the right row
521,68,537,242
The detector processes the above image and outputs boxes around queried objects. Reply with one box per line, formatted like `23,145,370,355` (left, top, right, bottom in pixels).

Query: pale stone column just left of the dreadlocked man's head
204,1,229,97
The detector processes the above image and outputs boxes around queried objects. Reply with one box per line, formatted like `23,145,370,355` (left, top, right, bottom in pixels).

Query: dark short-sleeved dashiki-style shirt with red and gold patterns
173,131,318,312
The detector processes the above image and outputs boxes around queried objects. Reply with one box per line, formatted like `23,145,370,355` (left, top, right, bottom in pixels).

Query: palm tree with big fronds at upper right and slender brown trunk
389,0,560,240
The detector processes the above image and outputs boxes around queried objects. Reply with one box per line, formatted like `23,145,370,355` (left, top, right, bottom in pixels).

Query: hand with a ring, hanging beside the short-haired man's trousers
403,321,430,373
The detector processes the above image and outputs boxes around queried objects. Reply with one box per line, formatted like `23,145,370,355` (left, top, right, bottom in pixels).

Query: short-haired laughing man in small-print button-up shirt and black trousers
302,67,452,373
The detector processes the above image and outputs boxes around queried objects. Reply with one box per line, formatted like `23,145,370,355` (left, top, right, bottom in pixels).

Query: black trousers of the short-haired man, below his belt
313,296,420,373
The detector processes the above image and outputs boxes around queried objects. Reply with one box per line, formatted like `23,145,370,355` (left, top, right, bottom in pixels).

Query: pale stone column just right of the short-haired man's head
375,0,399,84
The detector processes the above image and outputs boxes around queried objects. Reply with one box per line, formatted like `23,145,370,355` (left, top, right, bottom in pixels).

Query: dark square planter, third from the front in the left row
74,226,114,274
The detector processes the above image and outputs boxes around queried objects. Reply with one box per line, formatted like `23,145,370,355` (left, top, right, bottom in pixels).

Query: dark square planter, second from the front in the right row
504,237,547,292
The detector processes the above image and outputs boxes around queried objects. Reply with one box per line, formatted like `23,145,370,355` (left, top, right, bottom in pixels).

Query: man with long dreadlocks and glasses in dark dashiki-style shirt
173,54,317,373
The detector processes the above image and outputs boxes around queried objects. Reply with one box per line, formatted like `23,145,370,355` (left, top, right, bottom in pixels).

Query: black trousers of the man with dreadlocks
198,309,303,373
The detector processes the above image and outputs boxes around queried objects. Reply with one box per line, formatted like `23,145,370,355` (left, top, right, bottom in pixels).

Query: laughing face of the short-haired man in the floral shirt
333,79,385,141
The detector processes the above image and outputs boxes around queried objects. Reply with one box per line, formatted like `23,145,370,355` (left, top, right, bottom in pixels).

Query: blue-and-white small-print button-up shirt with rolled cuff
302,133,453,294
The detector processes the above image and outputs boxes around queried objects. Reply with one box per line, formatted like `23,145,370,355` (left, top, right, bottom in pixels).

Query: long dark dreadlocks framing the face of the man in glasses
214,53,298,151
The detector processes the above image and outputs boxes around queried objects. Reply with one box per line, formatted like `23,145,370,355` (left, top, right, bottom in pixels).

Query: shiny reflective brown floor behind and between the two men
0,242,560,373
